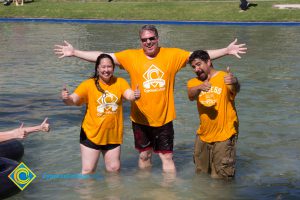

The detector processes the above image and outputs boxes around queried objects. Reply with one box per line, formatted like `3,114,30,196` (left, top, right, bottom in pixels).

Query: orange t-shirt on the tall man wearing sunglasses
115,47,190,127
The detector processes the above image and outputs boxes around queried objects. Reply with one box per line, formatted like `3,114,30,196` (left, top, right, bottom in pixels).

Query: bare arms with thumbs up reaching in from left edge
0,118,50,142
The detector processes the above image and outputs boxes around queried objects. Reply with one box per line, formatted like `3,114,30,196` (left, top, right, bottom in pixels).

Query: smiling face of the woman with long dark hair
97,58,114,83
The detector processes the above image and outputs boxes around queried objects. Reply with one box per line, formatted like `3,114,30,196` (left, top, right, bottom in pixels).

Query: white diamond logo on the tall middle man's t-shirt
143,65,166,92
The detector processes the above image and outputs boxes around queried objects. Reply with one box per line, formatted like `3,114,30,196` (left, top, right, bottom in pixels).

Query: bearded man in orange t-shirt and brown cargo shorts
187,50,240,178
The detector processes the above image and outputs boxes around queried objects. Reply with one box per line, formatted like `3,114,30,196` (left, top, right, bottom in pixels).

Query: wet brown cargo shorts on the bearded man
194,134,237,179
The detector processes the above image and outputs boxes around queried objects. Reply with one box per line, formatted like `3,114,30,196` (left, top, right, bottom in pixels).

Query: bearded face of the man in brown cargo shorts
191,58,211,81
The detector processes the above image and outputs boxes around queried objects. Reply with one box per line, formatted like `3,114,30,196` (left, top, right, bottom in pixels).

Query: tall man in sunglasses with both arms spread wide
54,25,247,172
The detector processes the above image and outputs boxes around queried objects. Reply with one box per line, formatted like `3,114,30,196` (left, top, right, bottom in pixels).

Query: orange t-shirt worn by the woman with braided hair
74,77,130,145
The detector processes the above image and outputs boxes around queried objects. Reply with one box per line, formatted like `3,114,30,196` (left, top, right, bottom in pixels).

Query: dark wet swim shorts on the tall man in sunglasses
132,122,174,153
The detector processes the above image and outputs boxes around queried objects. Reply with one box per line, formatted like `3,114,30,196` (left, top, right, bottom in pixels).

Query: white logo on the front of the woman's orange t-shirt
97,91,118,114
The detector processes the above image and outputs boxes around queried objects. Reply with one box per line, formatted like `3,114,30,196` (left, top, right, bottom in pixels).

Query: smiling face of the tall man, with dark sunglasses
140,30,159,58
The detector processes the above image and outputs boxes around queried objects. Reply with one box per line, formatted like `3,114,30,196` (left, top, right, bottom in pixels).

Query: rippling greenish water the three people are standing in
0,23,300,200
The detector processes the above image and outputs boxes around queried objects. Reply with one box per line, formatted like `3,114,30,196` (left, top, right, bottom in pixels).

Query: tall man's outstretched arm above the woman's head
54,41,119,65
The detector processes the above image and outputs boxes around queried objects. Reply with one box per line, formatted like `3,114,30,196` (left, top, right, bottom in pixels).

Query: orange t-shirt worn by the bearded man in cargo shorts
187,71,239,143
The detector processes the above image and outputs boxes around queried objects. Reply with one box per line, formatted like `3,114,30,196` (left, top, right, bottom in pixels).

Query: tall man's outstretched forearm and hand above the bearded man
207,39,247,59
